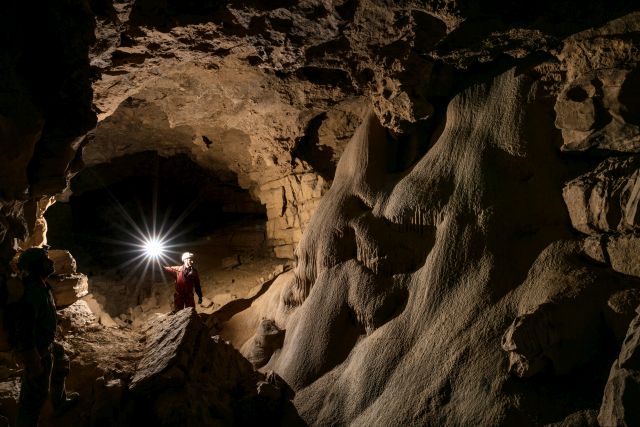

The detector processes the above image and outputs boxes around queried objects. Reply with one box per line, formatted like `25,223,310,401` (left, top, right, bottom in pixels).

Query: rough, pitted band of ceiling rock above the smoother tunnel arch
92,1,456,132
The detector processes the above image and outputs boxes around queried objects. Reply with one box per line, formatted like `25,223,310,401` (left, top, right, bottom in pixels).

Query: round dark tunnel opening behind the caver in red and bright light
45,151,275,321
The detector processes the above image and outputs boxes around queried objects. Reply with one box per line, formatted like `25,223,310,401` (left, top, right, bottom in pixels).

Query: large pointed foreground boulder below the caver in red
129,308,281,426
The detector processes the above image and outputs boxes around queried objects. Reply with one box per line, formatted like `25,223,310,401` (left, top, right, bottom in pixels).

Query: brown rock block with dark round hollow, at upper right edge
555,12,640,152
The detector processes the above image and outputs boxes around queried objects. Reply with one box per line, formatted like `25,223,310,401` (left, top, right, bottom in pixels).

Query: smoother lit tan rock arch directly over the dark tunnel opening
83,63,366,188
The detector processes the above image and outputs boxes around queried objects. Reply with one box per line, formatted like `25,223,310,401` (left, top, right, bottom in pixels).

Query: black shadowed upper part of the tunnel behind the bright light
46,152,266,274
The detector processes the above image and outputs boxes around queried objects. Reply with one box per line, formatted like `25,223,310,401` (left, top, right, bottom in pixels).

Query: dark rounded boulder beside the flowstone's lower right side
502,241,640,377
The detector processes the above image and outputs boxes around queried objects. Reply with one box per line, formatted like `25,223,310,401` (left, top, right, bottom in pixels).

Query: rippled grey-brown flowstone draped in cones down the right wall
229,55,637,425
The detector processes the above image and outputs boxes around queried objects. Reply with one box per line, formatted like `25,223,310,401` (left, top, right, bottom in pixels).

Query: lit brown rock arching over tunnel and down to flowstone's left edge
83,1,451,258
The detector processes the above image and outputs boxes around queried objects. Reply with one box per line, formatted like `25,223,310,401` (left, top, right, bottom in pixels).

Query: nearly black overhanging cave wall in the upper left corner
0,1,96,271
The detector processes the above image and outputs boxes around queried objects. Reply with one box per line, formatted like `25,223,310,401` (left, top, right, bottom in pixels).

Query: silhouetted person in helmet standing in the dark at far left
12,247,78,427
